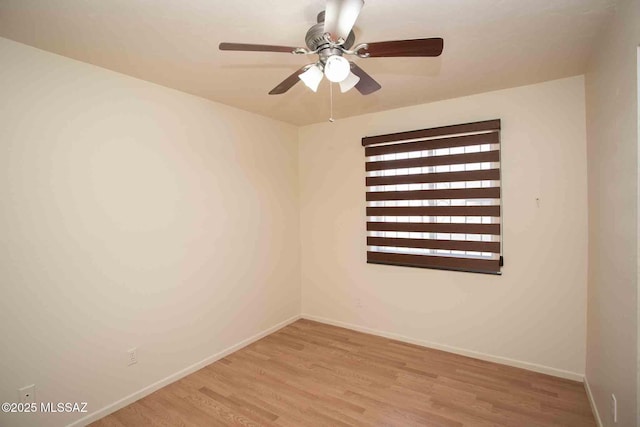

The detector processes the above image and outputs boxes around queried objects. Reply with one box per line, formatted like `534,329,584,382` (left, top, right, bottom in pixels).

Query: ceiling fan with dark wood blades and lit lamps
219,0,444,95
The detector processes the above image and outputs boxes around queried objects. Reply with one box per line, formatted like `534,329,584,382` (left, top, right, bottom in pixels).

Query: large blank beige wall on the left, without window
0,39,300,425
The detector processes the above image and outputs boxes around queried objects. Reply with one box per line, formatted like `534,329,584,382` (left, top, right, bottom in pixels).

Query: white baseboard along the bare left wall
68,315,300,427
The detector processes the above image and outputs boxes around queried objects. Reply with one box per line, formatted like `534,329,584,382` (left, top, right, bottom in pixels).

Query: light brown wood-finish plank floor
92,320,596,427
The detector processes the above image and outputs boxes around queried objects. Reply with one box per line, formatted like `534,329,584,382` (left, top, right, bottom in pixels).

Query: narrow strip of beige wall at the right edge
586,0,640,426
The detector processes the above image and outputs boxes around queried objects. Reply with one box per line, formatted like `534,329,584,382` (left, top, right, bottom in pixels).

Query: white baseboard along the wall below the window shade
301,313,584,382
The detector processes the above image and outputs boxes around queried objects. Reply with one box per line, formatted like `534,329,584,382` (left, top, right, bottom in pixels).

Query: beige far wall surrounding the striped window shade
299,77,587,379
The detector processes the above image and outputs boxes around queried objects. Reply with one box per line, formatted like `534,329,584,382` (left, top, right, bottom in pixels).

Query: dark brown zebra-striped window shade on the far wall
362,120,502,274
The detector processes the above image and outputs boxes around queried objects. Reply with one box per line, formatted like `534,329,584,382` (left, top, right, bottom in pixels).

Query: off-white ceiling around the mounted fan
0,0,615,125
